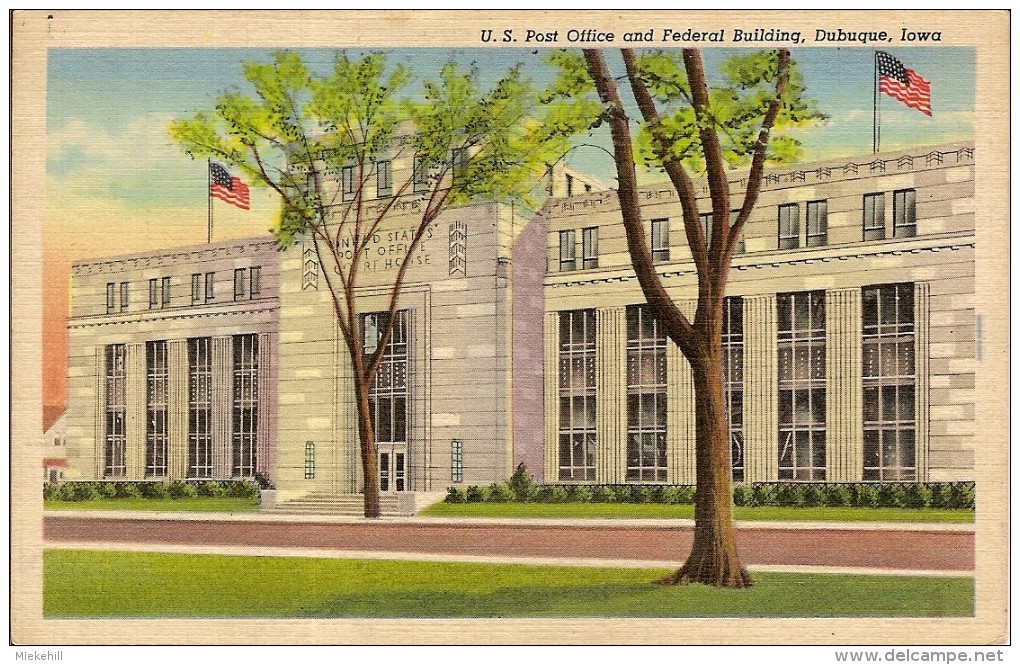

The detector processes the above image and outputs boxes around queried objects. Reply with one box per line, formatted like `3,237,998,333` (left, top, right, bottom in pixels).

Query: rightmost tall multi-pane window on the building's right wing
861,284,917,480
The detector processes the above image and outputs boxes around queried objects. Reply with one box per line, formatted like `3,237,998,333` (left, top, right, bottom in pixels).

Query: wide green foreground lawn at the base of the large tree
43,550,974,618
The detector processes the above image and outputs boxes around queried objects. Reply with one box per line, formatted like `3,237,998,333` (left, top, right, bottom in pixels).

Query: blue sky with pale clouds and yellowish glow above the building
47,47,975,242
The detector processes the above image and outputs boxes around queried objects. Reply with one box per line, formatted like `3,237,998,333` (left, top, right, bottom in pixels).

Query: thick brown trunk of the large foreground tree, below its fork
658,316,753,589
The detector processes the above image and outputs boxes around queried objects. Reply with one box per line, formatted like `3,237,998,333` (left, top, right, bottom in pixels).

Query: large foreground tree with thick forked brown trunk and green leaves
551,49,821,587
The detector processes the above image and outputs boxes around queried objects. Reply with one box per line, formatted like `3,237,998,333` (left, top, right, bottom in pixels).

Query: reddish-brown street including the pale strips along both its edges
44,511,974,574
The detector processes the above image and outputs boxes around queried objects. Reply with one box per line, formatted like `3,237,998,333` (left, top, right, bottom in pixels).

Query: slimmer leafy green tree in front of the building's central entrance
170,52,579,517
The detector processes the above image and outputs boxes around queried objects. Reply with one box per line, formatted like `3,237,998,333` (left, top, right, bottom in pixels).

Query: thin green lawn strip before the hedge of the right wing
420,503,974,522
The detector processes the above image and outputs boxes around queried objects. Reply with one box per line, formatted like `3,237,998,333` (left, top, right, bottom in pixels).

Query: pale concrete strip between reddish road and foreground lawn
45,542,974,577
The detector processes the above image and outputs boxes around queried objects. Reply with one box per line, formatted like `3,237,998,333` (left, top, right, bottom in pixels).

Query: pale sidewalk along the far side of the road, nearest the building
43,510,974,532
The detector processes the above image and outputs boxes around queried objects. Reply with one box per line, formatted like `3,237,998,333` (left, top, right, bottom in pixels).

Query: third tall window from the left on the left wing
188,338,212,478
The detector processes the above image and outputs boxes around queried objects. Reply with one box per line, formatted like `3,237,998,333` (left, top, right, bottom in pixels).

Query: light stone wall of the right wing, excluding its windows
545,144,976,482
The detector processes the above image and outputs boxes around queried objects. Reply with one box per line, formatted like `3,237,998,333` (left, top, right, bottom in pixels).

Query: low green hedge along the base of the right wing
446,481,974,510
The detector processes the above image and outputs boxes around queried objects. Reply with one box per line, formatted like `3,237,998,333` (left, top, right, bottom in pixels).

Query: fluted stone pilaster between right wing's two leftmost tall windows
595,307,627,483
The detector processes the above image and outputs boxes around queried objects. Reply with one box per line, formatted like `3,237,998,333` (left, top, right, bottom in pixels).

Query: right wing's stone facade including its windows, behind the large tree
544,144,979,483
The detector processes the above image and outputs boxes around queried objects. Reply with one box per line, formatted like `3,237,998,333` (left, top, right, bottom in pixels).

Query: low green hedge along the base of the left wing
43,480,259,501
